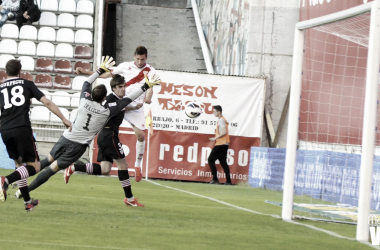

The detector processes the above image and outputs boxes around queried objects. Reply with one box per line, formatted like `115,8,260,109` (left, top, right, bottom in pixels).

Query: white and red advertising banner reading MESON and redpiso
93,71,265,183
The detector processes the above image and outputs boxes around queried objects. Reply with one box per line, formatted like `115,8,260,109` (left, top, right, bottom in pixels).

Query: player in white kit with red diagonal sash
76,46,156,182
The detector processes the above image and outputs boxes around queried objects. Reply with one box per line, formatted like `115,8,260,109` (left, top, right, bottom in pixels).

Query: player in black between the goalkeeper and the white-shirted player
63,75,144,207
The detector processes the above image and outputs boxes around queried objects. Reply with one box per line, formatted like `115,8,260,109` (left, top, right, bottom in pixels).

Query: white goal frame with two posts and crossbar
282,0,380,241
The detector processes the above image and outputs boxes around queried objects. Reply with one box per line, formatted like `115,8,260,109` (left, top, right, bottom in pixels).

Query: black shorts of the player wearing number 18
1,126,40,162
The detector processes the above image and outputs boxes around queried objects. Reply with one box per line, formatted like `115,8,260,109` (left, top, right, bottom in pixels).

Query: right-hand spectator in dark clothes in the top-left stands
17,0,41,29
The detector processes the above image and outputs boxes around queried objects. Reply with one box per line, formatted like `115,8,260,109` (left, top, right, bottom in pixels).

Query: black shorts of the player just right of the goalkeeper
97,128,125,163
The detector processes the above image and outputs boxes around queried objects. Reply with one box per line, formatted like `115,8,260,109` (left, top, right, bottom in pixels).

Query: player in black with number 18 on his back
0,60,71,211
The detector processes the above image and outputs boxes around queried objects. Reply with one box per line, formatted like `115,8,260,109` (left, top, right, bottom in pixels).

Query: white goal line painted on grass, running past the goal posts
145,180,380,250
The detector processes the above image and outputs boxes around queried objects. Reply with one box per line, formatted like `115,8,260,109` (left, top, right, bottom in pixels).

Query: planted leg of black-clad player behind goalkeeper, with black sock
114,157,144,207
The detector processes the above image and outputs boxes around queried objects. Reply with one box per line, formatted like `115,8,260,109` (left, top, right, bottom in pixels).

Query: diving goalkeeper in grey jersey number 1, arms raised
15,56,159,207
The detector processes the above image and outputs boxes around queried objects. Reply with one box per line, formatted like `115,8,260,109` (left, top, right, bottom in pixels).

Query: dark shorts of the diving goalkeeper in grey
50,136,88,169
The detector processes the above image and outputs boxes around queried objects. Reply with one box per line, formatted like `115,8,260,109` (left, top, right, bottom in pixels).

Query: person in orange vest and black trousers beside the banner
208,105,232,185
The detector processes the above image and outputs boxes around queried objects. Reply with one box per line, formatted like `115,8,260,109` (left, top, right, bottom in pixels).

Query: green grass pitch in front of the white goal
0,169,372,250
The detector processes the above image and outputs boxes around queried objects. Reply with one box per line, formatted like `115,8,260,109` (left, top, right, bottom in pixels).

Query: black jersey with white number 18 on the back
0,77,44,130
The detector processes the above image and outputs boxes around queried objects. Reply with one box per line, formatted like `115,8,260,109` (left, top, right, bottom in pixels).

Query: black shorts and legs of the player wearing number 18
0,127,40,202
